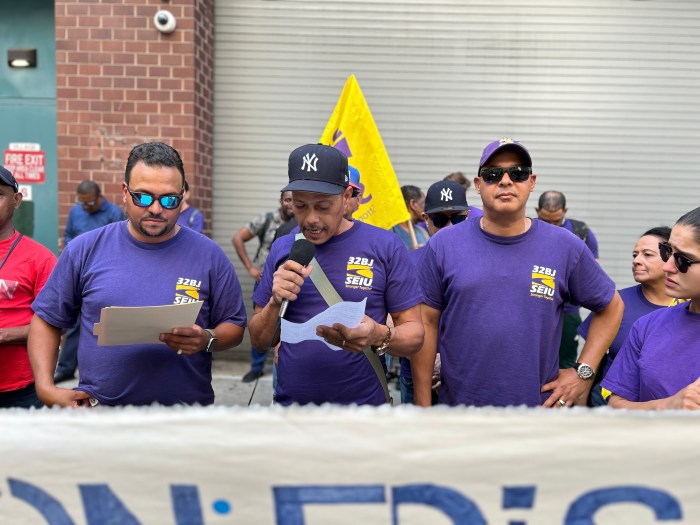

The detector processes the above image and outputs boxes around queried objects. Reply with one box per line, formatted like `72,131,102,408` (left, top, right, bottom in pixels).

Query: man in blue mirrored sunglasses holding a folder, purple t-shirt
28,142,246,407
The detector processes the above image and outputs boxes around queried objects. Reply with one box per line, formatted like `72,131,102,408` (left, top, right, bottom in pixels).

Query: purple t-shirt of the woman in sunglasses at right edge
601,303,700,402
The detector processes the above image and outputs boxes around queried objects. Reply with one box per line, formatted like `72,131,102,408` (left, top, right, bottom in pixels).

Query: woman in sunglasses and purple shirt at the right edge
602,208,700,410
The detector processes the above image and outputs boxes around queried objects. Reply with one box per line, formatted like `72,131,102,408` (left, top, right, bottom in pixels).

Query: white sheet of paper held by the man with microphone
280,299,367,350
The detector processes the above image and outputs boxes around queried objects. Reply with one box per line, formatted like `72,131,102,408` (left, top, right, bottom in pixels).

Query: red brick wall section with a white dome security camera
55,0,214,244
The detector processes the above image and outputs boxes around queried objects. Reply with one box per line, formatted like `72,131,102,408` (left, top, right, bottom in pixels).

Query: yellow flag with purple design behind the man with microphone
320,75,410,230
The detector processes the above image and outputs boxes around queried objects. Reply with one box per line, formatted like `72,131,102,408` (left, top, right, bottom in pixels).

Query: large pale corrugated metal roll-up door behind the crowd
214,0,700,302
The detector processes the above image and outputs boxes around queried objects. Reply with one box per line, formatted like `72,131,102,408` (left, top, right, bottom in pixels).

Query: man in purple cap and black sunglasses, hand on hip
411,139,623,407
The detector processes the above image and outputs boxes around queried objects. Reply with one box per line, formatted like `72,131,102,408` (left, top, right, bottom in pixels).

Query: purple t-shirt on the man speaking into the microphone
253,221,421,405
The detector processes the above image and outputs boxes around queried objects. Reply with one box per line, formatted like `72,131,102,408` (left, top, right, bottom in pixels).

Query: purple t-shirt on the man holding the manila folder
32,221,246,405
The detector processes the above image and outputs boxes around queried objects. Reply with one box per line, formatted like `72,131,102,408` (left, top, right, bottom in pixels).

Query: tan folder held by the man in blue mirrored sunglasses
92,301,203,346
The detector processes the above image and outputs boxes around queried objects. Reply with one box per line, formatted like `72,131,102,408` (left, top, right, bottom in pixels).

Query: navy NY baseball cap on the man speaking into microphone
282,144,350,195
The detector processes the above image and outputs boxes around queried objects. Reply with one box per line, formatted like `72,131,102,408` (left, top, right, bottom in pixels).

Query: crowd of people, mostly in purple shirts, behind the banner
0,139,700,410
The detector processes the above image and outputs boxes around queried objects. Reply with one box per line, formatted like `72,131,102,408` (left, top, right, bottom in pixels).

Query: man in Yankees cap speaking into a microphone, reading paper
250,144,423,405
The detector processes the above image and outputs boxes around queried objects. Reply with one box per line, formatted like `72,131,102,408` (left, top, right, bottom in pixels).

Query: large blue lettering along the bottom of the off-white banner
7,478,683,525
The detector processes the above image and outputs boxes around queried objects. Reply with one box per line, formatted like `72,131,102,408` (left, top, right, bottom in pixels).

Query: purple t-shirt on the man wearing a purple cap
418,217,615,406
